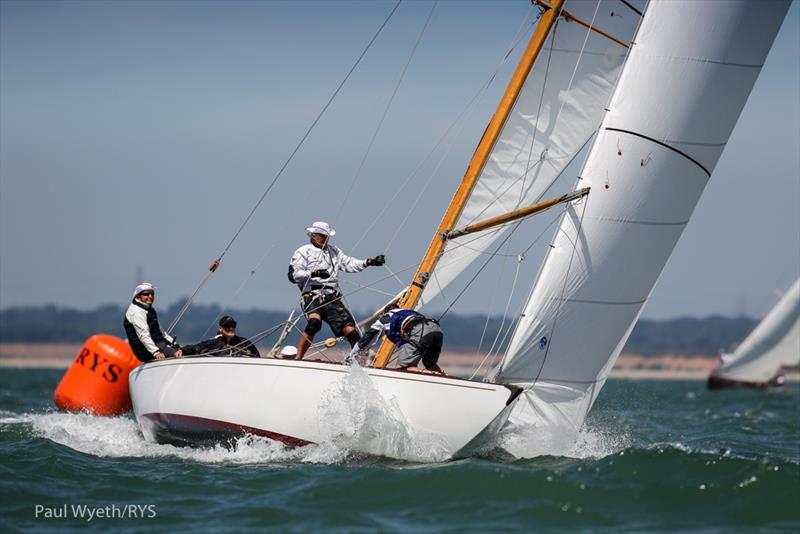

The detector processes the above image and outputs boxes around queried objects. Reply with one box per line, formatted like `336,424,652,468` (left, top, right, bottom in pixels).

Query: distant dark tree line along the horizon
0,304,756,356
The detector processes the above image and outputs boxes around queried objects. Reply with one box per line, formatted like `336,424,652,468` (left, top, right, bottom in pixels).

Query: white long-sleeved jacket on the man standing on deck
289,243,367,294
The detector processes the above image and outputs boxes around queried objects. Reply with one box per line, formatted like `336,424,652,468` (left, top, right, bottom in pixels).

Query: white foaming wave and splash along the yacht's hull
0,364,629,464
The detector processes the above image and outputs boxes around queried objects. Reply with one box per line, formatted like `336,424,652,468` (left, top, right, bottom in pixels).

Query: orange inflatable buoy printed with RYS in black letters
53,334,142,415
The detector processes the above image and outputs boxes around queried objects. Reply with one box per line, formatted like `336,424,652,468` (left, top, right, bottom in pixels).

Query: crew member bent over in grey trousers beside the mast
350,308,446,376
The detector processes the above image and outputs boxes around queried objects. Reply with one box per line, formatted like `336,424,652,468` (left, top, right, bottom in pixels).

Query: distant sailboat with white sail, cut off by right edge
714,278,800,384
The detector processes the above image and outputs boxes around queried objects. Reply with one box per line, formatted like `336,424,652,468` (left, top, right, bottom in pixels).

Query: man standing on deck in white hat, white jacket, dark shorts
289,221,385,360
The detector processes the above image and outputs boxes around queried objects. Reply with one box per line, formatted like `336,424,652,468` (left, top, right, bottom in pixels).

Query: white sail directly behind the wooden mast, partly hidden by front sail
421,0,644,305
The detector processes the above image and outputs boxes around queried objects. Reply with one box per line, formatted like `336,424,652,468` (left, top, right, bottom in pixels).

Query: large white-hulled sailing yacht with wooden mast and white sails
130,0,789,459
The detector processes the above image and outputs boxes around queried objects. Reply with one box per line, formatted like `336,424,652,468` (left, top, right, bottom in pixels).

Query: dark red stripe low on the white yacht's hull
142,413,313,447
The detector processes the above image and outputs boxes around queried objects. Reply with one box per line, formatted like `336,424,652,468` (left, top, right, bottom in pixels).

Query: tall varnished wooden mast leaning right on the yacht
374,0,564,367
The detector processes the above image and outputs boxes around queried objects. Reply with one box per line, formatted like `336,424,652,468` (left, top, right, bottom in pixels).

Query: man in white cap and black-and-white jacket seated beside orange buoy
123,282,183,362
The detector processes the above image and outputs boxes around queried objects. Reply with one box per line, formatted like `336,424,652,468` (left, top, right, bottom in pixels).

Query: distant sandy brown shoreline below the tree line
0,343,800,382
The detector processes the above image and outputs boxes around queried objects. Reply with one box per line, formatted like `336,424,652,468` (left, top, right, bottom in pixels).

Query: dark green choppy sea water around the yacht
0,369,800,532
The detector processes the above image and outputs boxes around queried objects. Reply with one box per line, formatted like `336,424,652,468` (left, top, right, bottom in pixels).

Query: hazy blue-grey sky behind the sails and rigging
0,0,800,319
